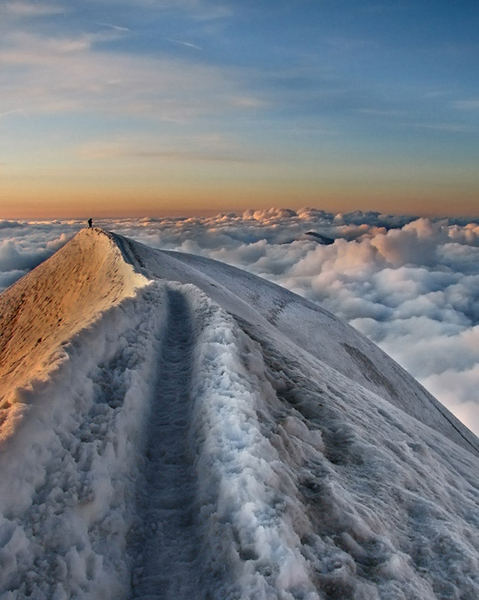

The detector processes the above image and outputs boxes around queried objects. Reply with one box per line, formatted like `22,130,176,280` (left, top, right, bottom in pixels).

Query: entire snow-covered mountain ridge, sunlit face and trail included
0,230,479,600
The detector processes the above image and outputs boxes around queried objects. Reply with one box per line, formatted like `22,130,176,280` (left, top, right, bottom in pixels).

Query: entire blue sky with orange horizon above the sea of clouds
0,0,479,218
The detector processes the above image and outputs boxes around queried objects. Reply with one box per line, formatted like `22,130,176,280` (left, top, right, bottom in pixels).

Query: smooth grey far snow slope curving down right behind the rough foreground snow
111,227,479,455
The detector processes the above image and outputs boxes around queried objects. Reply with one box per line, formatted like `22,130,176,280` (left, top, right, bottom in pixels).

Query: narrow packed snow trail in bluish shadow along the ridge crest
132,289,204,600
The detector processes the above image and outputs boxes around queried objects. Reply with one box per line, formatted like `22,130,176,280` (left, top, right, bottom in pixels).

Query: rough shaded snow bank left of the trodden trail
0,288,168,599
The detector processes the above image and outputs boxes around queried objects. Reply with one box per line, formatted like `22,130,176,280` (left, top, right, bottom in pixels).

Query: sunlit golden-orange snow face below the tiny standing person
0,229,147,410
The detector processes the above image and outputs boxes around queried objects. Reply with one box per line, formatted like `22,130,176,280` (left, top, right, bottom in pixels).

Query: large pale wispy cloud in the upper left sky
0,28,260,122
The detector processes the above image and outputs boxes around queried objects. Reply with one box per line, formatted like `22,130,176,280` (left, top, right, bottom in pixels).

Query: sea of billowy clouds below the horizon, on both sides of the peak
0,208,479,434
